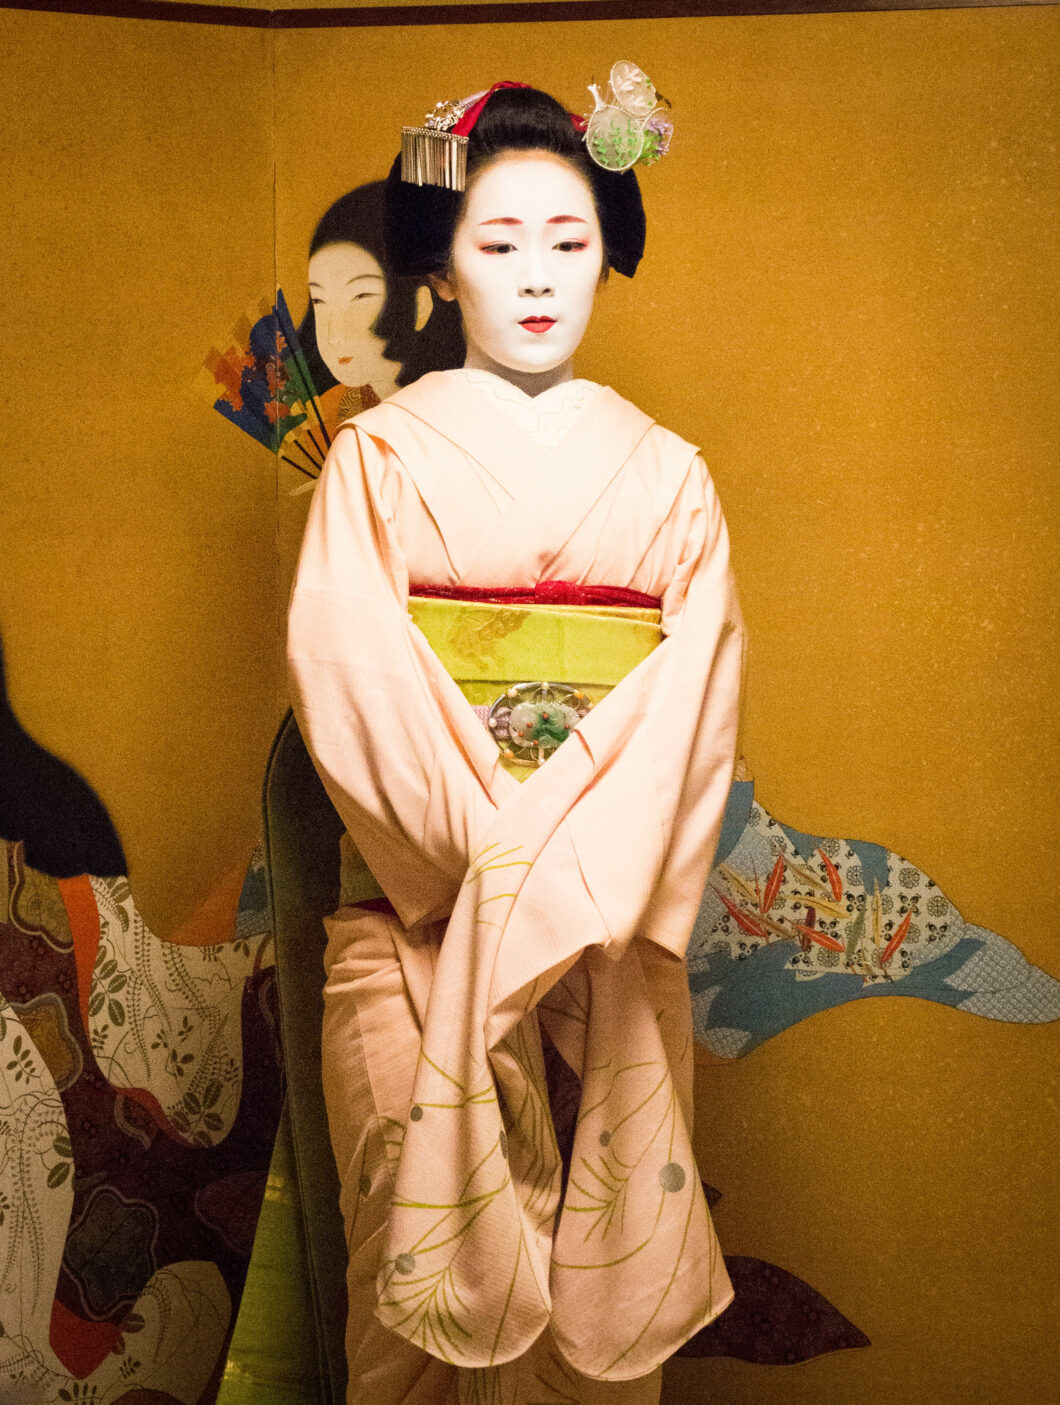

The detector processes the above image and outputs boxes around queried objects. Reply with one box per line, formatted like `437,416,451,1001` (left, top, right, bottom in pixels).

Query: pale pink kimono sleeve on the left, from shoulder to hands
287,427,508,927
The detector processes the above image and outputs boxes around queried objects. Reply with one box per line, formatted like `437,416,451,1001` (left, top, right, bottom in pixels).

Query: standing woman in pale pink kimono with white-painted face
288,76,741,1405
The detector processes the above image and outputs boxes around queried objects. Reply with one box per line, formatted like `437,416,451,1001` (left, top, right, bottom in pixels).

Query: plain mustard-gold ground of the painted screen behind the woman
0,7,1060,1405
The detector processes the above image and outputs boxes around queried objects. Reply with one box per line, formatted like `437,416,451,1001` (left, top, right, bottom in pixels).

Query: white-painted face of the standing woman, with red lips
432,152,603,393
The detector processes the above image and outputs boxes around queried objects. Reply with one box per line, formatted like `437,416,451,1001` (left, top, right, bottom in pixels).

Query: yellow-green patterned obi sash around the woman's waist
340,596,662,903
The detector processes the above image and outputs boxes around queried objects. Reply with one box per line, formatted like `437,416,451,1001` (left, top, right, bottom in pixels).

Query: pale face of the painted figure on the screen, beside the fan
309,243,399,387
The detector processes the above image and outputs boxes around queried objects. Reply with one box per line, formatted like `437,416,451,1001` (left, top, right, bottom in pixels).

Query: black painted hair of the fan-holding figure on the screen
298,180,464,395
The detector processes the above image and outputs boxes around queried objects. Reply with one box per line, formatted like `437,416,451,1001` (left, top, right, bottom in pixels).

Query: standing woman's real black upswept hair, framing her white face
385,89,647,278
